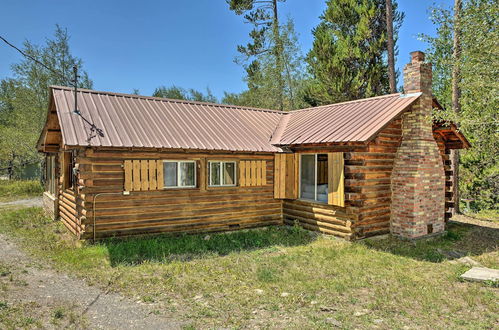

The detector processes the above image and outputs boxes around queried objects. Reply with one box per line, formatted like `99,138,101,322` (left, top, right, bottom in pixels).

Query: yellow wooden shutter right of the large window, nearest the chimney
328,152,345,206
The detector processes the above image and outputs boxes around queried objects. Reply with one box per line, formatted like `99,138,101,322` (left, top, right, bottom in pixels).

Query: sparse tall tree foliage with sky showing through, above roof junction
226,0,304,110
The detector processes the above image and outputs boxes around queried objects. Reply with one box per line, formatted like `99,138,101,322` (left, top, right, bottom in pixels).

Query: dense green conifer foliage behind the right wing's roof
305,0,404,106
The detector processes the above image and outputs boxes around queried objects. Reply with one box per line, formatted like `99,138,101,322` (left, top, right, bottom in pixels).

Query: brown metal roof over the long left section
51,86,282,152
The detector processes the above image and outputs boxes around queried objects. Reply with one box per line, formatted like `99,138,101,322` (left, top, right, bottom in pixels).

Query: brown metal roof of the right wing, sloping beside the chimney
272,93,421,145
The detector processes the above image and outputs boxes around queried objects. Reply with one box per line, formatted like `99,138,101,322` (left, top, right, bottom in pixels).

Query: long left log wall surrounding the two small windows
78,149,282,238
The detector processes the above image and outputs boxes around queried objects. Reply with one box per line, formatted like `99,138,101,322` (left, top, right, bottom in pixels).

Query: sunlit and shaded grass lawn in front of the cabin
0,208,499,329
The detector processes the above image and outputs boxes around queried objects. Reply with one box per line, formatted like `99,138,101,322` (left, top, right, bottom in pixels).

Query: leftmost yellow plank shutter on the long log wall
123,159,163,191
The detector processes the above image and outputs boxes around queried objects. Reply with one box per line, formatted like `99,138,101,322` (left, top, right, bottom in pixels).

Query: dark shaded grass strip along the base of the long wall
100,226,317,267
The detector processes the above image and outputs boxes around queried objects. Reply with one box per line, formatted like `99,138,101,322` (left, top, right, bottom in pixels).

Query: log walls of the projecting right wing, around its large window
283,120,402,239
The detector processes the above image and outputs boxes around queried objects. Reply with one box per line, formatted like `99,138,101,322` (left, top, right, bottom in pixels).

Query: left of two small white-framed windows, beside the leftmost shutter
163,160,196,188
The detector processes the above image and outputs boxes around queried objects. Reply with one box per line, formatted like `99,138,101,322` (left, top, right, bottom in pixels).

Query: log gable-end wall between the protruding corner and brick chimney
345,120,402,238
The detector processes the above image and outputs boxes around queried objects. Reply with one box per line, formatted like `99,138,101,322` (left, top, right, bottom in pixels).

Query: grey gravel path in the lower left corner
0,234,181,329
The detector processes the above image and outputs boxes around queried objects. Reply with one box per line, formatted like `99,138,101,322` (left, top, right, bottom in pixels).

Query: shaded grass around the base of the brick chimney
361,221,499,262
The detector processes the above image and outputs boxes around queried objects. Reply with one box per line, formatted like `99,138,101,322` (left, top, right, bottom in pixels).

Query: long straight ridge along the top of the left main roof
49,85,288,114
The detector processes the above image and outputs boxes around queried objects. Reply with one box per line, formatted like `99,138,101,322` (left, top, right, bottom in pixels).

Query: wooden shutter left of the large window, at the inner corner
274,154,298,199
